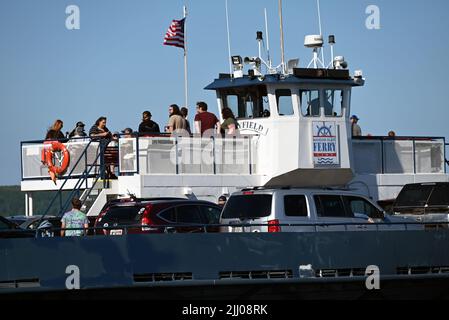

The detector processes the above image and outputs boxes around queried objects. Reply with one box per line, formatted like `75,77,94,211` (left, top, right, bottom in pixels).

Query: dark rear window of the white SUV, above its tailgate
222,194,273,219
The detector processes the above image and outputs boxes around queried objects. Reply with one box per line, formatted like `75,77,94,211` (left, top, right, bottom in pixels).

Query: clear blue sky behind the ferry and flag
0,0,449,185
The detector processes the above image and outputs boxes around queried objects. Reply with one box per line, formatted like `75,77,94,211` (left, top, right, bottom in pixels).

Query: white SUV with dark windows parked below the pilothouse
220,188,423,232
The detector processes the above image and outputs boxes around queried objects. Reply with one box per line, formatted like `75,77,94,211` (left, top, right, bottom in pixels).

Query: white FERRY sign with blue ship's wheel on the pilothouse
312,121,340,166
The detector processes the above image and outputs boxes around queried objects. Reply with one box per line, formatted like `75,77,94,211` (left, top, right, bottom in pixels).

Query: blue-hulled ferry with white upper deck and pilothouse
0,2,449,299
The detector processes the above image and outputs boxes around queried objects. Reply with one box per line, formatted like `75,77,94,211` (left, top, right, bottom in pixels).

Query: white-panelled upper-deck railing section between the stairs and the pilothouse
119,136,255,175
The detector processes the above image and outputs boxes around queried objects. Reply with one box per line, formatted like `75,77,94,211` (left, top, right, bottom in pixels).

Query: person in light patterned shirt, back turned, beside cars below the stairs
61,198,89,237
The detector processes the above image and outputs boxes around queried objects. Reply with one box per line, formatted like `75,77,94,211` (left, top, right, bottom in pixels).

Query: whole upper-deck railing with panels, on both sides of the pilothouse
21,135,442,181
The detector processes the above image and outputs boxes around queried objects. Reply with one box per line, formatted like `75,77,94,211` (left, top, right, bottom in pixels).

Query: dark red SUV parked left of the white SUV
95,199,221,235
